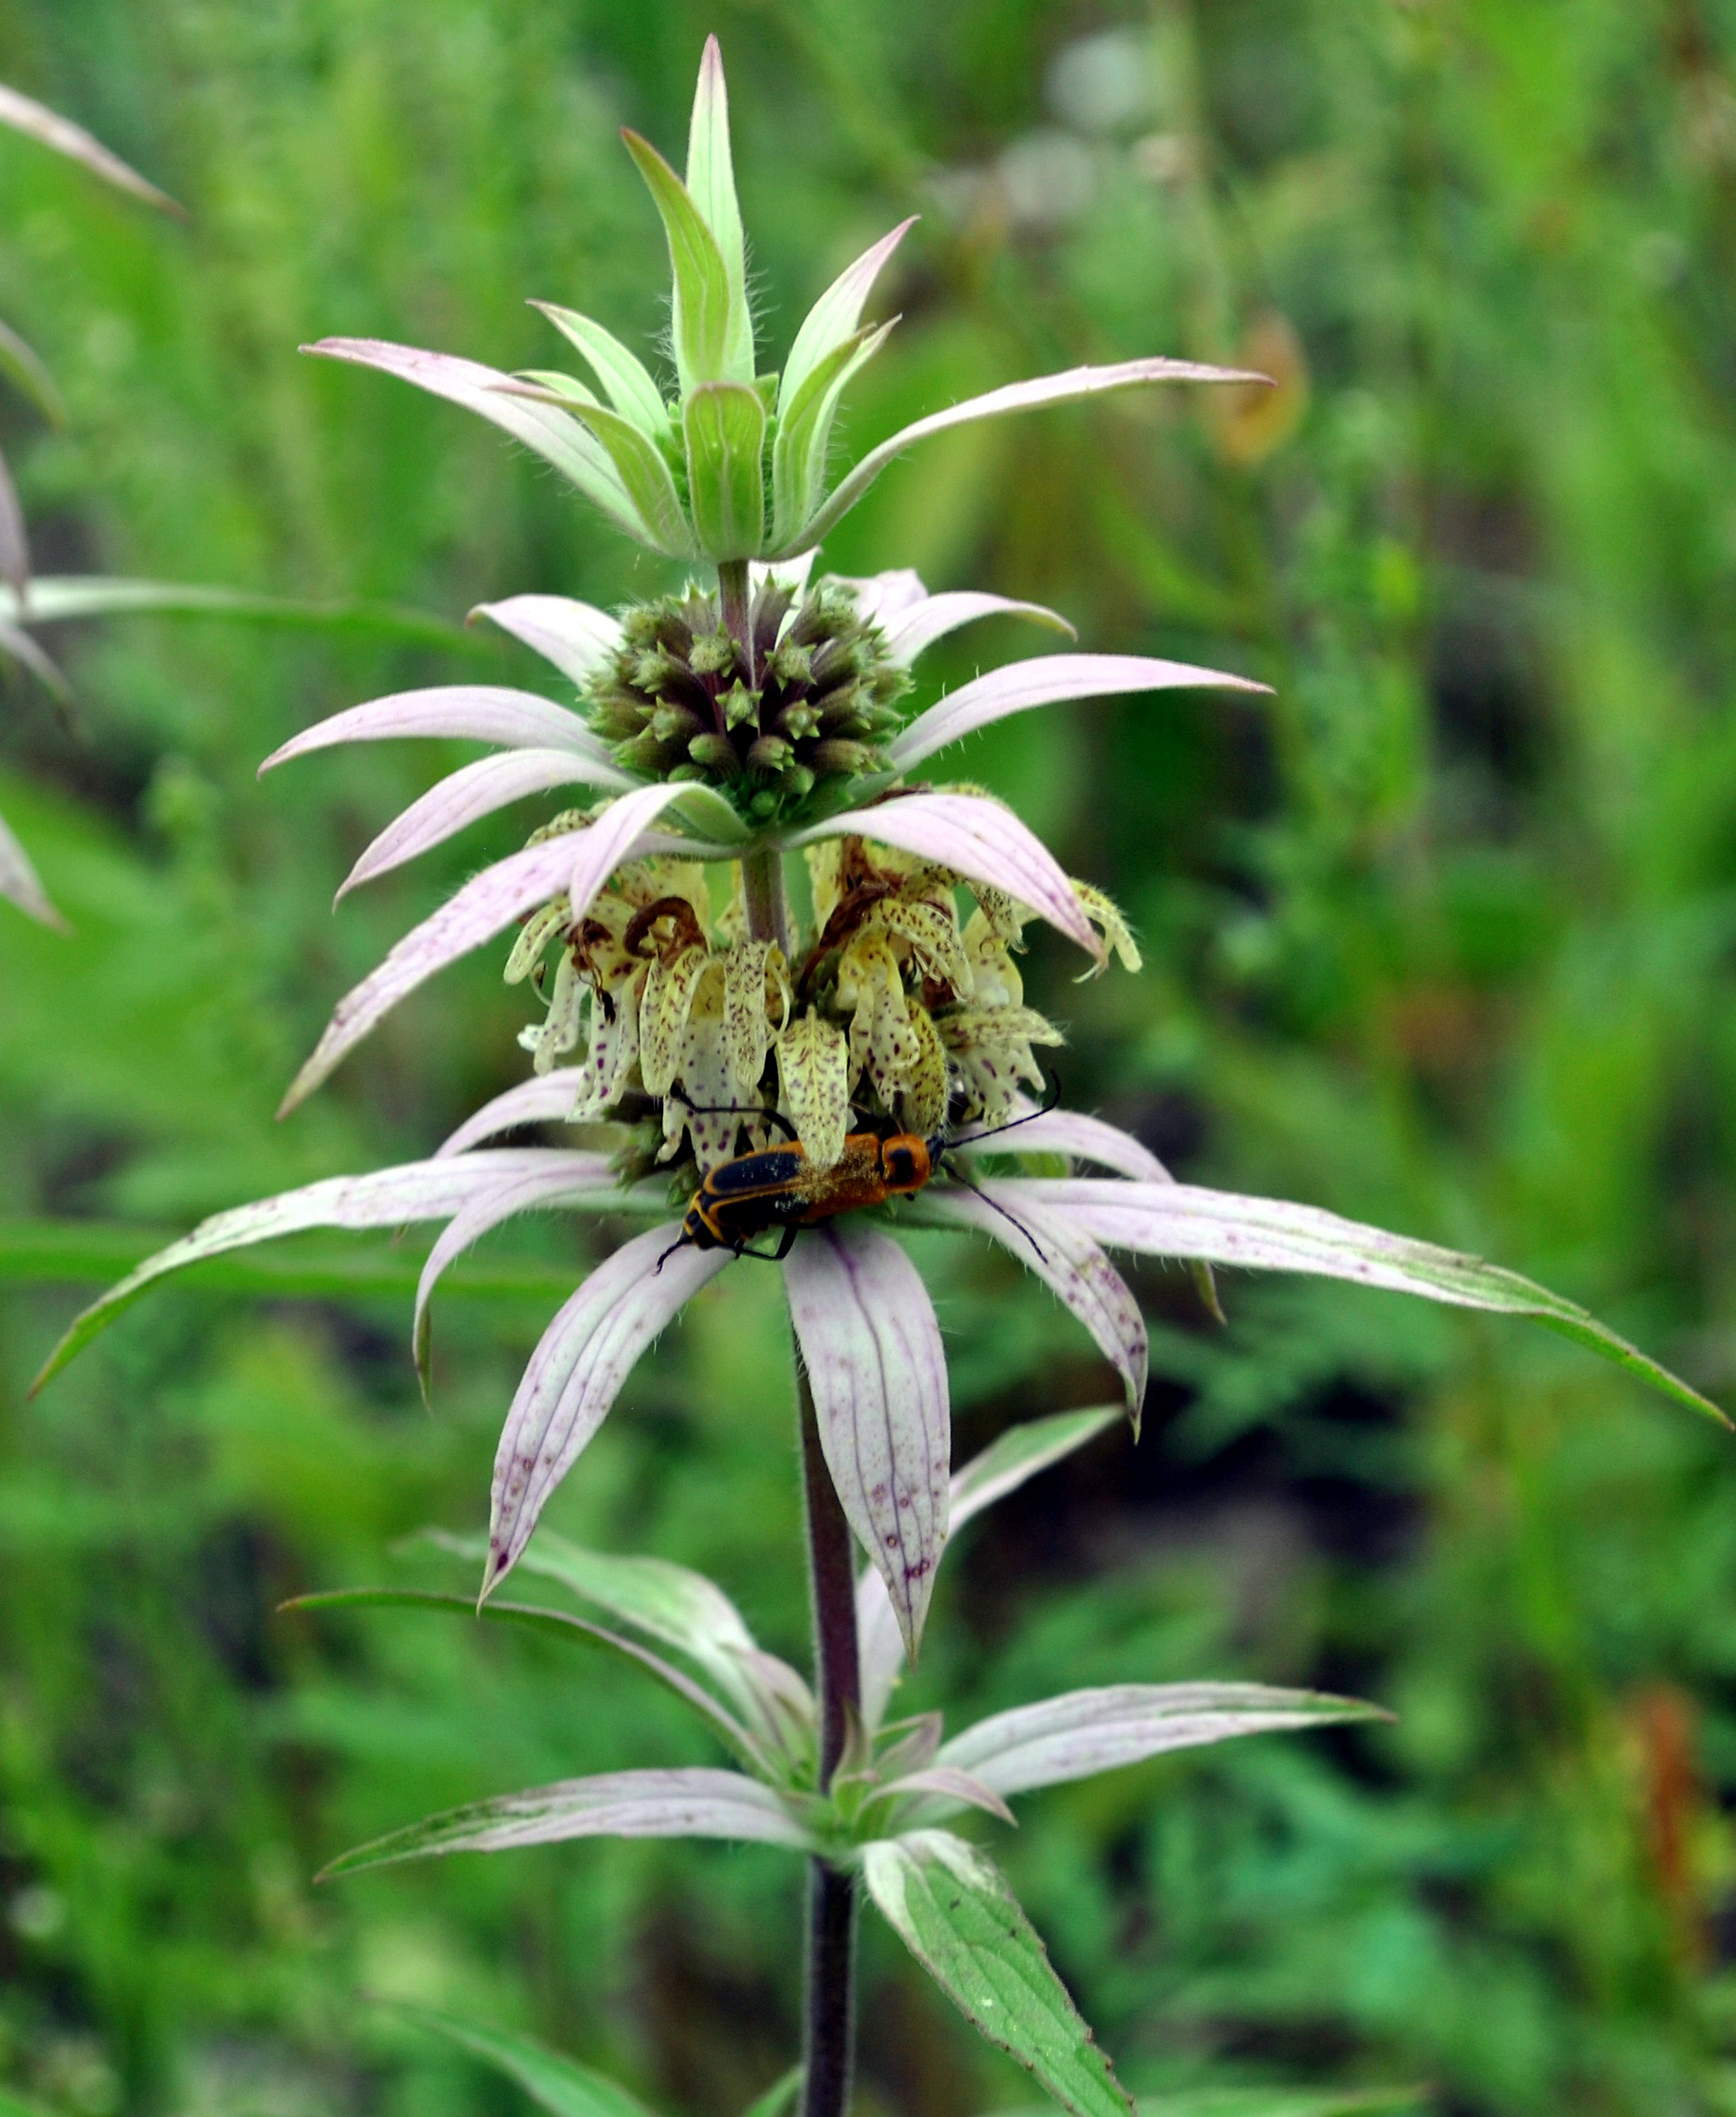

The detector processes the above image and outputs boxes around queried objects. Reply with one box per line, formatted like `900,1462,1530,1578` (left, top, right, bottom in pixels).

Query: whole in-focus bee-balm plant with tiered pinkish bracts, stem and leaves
33,42,1717,2117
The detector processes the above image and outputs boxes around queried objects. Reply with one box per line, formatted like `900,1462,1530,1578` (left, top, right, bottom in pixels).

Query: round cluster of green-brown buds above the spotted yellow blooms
587,578,910,823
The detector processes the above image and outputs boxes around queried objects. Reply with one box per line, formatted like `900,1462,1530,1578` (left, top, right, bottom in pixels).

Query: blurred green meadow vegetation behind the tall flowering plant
0,0,1736,2117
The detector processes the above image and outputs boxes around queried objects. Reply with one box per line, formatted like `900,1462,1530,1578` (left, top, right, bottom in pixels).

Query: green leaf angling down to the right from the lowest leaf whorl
862,1832,1133,2117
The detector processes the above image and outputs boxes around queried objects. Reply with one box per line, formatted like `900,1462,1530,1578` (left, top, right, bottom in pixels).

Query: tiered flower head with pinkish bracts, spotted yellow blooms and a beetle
33,29,1702,1649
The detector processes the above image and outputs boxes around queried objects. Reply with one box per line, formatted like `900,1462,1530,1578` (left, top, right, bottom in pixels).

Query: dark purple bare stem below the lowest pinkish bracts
796,1364,862,2117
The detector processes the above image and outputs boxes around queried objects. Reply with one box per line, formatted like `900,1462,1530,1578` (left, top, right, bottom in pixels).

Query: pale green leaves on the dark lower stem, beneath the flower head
287,1408,1369,2117
